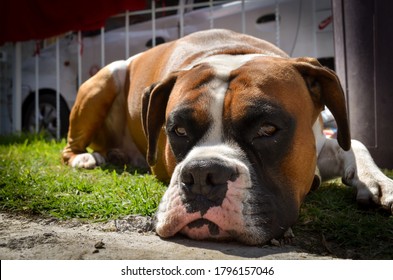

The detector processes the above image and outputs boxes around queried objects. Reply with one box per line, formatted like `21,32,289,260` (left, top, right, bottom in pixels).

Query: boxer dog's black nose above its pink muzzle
180,159,239,205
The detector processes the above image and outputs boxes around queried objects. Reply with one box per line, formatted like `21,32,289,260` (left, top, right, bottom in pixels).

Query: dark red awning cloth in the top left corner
0,0,148,45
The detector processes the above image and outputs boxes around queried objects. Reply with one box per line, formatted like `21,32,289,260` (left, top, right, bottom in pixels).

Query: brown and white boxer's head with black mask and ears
142,55,350,244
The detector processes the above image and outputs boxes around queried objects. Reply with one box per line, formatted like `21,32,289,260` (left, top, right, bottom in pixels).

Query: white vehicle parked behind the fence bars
22,0,334,136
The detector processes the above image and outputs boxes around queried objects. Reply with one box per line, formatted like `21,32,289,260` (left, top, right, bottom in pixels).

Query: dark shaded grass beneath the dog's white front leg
293,183,393,259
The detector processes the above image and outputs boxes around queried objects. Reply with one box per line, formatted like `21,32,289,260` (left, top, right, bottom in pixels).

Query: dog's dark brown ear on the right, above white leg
294,57,351,151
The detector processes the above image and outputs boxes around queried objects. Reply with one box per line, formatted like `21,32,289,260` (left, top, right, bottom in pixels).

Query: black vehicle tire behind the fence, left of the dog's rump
22,93,70,138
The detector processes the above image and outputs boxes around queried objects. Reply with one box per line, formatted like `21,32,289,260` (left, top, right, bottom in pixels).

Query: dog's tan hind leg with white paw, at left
62,61,128,168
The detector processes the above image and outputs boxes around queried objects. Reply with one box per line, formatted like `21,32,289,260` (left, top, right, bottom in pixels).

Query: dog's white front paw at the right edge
355,172,393,214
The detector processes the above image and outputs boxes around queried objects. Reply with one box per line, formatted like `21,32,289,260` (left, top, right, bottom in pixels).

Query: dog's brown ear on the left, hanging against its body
142,72,178,166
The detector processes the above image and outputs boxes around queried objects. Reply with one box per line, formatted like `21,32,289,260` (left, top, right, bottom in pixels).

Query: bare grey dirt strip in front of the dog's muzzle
0,213,332,260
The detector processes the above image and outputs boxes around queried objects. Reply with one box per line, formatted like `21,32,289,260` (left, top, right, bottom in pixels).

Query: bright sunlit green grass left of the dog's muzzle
0,135,165,220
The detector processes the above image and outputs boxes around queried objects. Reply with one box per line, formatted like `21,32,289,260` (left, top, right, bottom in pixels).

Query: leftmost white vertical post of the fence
12,42,22,132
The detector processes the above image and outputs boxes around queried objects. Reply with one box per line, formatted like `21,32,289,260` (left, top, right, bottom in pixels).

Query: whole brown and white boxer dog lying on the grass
63,30,393,244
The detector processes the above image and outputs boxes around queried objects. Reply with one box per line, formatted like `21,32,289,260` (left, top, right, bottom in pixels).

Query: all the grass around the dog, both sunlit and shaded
0,135,393,259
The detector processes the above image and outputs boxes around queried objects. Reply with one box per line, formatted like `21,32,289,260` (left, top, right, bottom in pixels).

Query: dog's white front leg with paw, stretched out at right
318,139,393,213
